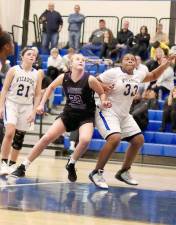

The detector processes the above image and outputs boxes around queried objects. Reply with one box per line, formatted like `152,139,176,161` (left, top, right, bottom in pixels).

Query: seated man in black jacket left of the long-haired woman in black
110,20,134,61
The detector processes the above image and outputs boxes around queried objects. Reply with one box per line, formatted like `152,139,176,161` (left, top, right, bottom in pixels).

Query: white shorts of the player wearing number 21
4,100,33,131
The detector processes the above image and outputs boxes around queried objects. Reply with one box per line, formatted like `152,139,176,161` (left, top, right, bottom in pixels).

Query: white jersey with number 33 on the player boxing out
99,67,146,117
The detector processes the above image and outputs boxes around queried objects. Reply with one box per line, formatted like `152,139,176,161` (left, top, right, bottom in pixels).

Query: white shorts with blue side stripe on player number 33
95,108,141,139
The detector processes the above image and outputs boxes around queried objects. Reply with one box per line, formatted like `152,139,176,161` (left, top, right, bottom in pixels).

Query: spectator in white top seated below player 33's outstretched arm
153,56,174,99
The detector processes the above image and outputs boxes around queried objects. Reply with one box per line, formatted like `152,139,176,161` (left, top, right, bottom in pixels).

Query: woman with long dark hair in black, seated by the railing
130,26,150,60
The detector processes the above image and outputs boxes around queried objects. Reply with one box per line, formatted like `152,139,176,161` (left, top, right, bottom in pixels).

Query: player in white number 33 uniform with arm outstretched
89,54,176,189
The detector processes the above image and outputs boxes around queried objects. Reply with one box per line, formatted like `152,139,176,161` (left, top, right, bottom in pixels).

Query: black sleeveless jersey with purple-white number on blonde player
62,72,95,114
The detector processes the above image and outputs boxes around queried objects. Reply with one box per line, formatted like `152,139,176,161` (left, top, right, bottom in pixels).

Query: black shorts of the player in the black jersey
57,112,95,132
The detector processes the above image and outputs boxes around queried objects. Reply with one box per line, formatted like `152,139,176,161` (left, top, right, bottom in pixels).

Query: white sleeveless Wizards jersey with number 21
6,65,38,104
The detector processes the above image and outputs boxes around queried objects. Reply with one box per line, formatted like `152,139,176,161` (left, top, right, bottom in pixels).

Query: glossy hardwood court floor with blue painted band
0,157,176,225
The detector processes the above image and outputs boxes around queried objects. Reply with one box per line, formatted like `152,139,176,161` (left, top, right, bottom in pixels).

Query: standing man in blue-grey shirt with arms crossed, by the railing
68,5,84,52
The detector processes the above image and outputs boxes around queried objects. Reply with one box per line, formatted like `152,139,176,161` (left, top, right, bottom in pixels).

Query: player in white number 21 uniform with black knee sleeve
0,48,41,175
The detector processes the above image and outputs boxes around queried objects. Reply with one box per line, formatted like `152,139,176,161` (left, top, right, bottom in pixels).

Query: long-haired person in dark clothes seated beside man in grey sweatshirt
100,31,117,58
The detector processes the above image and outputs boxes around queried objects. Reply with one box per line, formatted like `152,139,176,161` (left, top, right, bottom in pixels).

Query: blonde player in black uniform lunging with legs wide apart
11,54,111,182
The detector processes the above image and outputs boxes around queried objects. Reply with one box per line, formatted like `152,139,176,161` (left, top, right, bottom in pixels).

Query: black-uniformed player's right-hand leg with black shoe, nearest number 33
66,122,94,182
